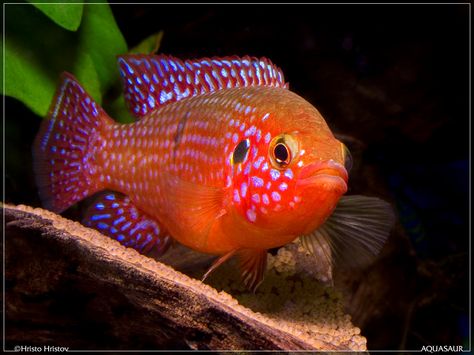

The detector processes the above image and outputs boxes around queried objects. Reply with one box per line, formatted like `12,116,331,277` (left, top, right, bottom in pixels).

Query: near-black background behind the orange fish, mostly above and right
5,4,470,349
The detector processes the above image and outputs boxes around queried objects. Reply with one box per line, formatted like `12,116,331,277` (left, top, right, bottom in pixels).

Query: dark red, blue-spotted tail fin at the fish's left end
33,73,110,213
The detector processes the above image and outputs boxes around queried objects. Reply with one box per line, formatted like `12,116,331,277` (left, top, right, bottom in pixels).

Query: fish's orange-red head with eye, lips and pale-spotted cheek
228,90,350,247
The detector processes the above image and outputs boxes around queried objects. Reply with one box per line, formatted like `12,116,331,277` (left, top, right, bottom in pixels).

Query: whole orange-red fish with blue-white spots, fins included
33,54,394,292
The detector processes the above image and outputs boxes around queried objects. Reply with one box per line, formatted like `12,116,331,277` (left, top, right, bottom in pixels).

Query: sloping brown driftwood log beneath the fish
3,205,365,350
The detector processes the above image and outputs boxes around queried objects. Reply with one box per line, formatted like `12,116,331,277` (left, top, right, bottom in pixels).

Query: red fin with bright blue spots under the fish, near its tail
82,192,171,254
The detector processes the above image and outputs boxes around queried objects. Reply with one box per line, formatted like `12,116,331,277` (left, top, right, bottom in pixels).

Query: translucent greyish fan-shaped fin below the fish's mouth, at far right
300,195,395,267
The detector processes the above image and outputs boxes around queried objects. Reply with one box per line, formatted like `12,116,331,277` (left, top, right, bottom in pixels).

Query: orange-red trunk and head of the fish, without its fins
91,87,347,254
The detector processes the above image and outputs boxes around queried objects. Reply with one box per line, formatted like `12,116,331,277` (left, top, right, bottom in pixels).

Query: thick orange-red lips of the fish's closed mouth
297,160,348,192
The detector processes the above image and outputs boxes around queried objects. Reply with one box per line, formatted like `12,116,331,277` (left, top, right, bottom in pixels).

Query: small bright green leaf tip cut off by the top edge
27,0,83,31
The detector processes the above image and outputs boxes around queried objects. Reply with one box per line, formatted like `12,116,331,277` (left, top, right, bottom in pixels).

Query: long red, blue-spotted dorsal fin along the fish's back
118,54,288,117
